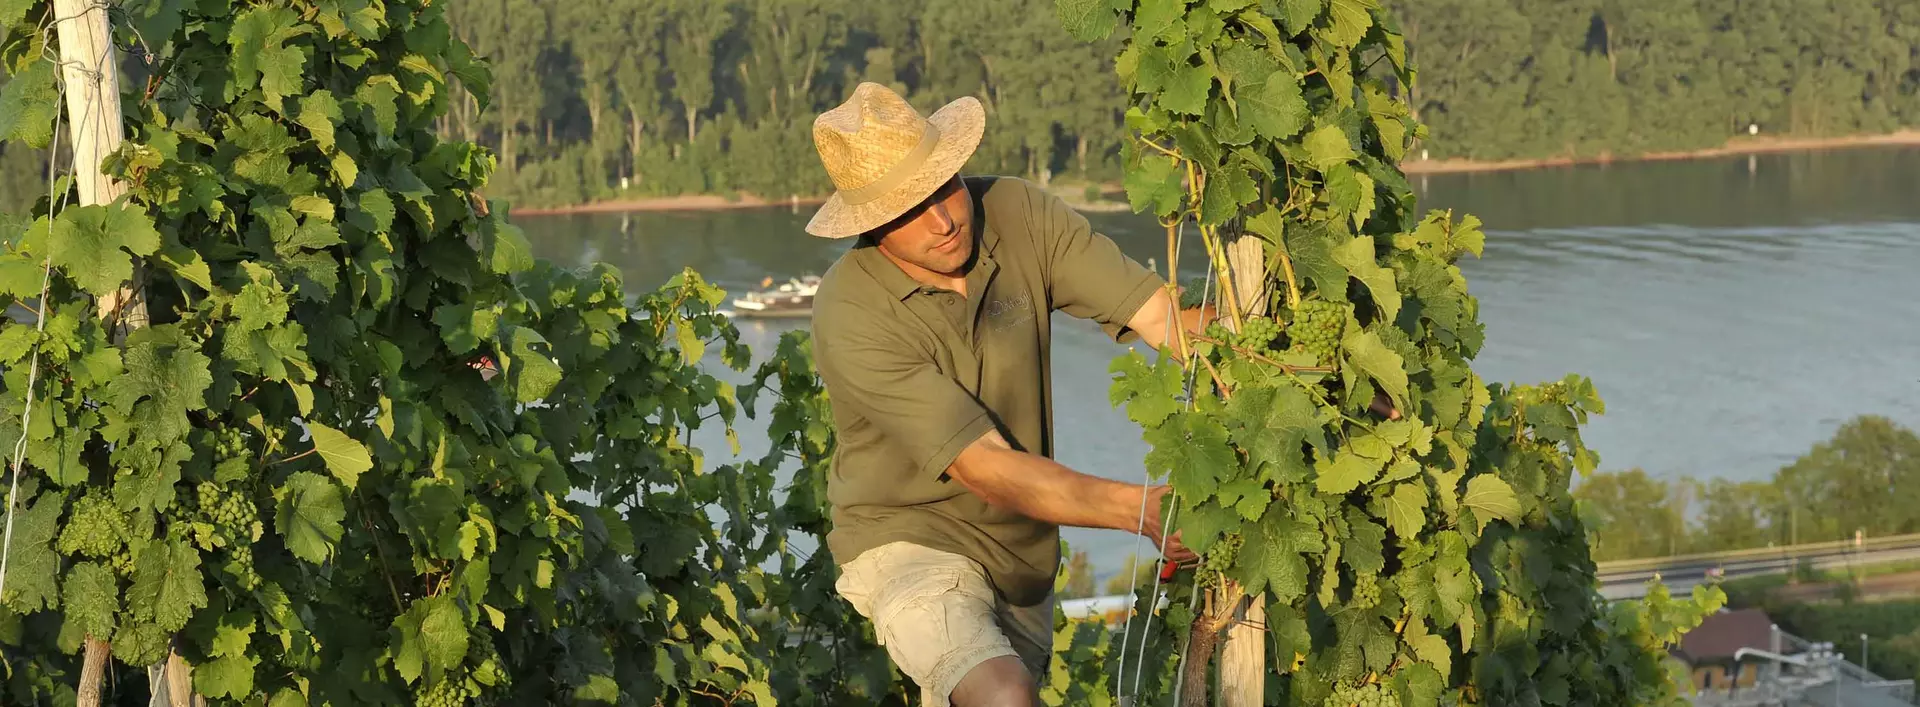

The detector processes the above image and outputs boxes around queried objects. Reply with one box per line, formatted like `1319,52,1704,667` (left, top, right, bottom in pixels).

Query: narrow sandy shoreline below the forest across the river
513,129,1920,215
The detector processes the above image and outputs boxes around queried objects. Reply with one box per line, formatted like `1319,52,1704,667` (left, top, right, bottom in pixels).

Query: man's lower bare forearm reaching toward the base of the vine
947,432,1196,561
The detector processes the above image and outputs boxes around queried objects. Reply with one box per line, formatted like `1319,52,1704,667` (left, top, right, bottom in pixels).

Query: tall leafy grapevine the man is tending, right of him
1058,0,1722,705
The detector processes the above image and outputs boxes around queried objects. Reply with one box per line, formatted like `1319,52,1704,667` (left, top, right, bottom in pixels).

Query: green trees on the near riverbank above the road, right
1574,415,1920,561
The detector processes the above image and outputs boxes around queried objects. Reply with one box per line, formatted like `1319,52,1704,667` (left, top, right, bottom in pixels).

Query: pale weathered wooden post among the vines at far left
54,0,180,707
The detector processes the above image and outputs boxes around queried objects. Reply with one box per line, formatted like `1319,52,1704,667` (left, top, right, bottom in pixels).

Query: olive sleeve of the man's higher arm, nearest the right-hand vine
1029,179,1165,342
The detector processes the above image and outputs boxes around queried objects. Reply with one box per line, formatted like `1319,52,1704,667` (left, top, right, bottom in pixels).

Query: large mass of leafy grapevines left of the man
0,0,899,705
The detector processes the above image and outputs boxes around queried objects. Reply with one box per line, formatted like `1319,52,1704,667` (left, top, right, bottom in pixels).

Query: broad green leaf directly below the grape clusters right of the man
1227,384,1327,484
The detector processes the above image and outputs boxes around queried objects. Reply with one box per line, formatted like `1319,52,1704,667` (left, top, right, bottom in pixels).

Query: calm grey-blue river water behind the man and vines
515,148,1920,574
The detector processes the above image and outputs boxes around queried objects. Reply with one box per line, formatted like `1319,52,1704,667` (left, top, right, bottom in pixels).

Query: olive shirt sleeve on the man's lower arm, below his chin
814,311,995,476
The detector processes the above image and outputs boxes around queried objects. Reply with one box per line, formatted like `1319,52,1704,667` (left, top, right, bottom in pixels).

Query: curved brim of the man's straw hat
806,96,987,238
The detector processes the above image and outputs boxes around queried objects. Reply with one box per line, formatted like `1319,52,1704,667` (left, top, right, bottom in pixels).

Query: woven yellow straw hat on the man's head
806,83,987,238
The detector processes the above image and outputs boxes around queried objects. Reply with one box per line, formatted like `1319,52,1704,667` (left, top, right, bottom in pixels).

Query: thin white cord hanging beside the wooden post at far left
0,2,113,599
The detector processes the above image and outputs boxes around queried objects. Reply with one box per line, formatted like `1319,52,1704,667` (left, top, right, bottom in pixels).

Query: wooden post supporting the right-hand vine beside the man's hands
1215,229,1267,707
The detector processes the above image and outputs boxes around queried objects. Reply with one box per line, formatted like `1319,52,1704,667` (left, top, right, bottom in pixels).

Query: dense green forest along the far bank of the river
0,0,1920,209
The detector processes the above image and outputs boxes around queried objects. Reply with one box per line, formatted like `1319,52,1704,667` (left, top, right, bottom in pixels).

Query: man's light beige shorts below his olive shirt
835,542,1054,707
